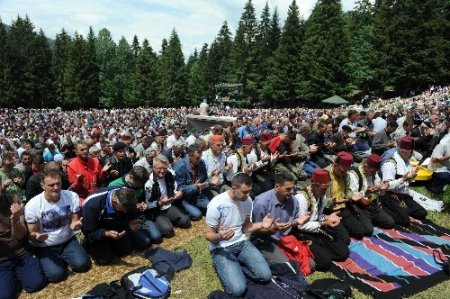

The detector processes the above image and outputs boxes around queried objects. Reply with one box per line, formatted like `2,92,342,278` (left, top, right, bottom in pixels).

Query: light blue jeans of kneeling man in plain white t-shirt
211,240,272,297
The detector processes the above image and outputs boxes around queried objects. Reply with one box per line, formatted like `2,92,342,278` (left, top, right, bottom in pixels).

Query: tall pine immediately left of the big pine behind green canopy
262,0,304,105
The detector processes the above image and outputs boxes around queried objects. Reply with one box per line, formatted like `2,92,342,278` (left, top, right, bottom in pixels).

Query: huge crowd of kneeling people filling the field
0,87,450,298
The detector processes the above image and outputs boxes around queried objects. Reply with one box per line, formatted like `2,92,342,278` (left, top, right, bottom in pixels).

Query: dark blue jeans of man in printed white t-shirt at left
36,237,91,282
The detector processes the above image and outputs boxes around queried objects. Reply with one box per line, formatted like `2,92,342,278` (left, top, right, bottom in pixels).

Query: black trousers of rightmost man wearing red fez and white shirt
380,193,427,226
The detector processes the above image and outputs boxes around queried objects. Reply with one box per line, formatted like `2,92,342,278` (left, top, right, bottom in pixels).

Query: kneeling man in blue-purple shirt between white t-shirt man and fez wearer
252,172,310,264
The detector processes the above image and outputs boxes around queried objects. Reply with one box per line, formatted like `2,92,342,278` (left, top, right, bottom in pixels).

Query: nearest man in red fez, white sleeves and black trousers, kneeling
295,168,350,271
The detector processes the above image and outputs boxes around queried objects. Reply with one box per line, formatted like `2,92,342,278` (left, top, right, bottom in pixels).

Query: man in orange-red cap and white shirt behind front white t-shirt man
202,135,233,198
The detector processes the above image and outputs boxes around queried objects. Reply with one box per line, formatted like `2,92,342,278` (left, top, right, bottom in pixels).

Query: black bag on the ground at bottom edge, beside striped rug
303,278,353,299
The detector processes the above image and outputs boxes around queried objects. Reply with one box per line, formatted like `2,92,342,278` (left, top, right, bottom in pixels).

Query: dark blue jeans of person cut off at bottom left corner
0,251,46,299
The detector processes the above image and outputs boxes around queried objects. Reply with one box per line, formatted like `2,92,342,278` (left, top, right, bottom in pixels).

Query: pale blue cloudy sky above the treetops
0,0,355,56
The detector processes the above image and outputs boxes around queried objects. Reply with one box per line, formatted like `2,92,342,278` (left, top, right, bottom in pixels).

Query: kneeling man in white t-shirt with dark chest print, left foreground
25,170,90,282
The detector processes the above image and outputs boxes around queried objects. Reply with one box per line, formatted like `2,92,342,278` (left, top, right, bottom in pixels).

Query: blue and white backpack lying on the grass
120,266,170,299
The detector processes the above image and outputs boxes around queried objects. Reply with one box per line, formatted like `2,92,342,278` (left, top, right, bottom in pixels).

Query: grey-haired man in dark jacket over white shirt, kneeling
145,155,191,237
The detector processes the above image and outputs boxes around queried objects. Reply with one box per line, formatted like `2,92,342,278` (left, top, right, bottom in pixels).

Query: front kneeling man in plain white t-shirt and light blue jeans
205,173,273,297
